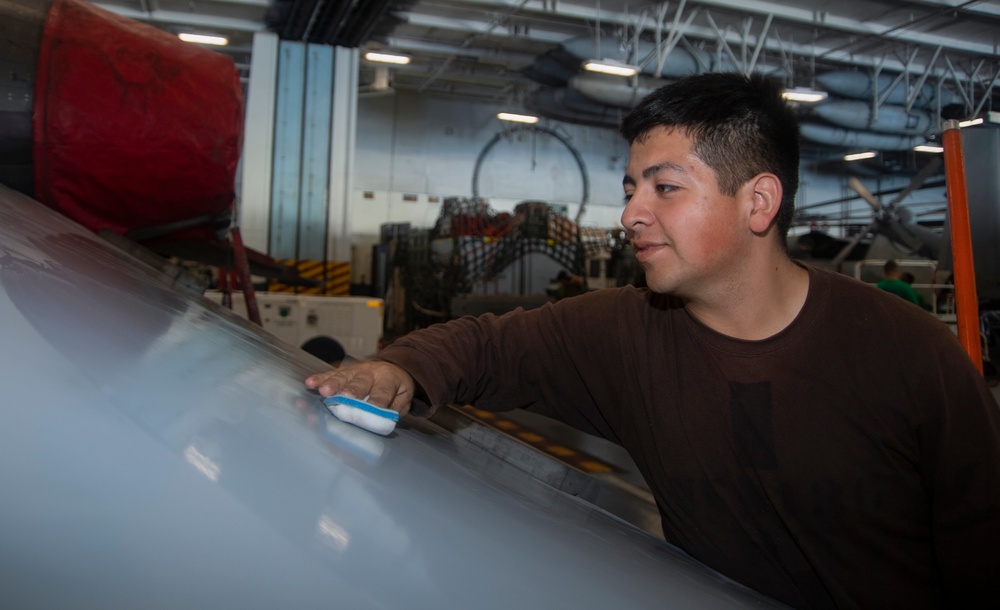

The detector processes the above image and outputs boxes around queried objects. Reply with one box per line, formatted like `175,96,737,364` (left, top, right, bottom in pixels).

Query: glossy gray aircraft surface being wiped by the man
0,187,782,609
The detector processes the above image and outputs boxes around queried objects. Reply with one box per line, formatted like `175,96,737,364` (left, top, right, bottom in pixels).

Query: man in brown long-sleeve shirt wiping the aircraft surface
306,74,1000,609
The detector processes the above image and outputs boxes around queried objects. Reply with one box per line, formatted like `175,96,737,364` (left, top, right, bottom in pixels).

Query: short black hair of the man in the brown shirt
621,72,799,247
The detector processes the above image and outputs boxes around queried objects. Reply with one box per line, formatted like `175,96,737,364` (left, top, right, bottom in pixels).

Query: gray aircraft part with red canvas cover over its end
0,0,308,324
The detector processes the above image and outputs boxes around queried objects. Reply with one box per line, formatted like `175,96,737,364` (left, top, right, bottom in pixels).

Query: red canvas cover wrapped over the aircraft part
32,0,243,235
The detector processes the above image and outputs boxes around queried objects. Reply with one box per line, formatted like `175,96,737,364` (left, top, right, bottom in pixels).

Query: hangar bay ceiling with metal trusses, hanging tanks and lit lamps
95,0,1000,151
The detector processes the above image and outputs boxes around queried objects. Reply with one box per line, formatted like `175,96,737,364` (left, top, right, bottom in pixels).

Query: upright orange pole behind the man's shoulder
941,121,983,373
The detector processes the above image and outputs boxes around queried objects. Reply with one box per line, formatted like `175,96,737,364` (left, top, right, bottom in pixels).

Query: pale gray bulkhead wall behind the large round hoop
355,91,628,233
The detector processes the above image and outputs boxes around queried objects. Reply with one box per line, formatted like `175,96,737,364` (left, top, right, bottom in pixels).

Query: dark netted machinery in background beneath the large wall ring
372,197,644,332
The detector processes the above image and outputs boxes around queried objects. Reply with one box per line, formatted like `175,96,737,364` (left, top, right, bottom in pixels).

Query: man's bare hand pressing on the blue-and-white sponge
306,360,416,415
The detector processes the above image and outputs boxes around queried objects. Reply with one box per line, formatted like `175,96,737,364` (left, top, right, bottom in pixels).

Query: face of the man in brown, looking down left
622,127,751,298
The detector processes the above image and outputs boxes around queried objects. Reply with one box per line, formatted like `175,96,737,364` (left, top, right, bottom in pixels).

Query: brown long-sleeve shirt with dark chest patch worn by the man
379,268,1000,609
